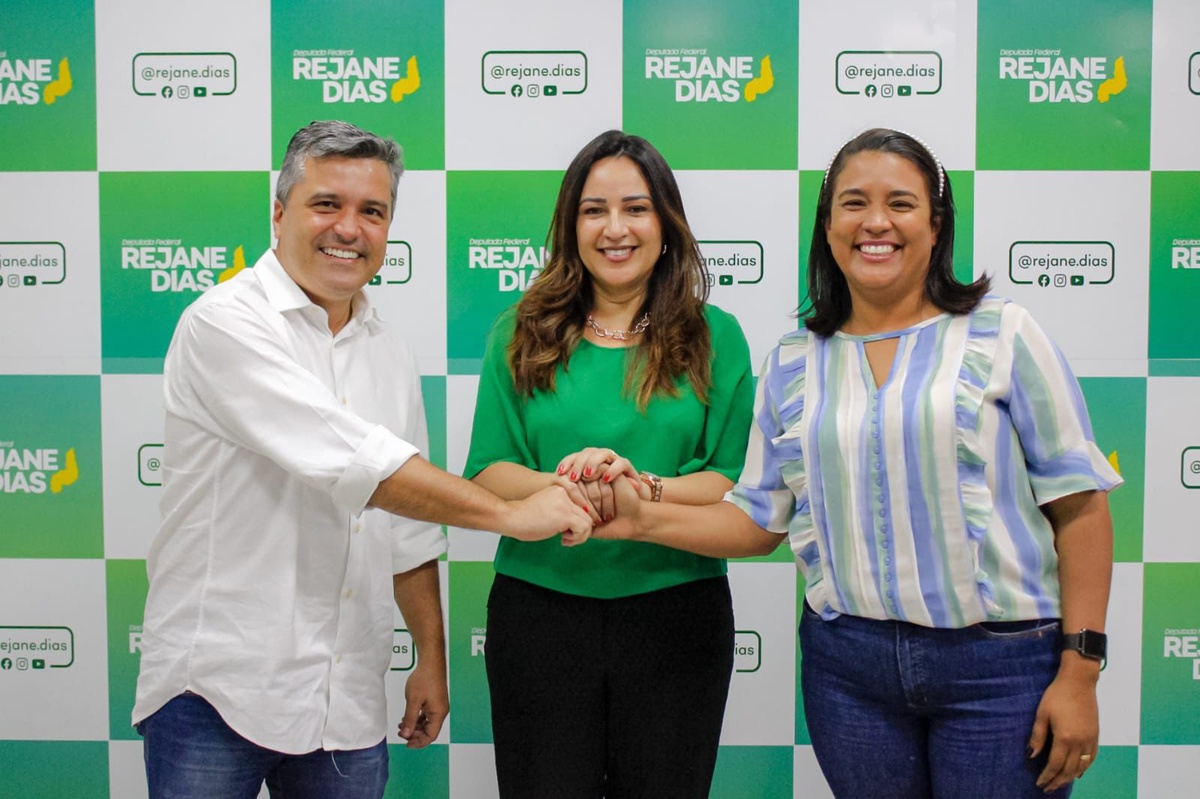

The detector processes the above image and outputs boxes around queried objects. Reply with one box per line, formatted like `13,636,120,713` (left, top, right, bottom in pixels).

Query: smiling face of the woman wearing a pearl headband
826,150,938,305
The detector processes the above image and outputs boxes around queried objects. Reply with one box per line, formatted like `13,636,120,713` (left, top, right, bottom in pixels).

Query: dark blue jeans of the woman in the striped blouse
800,605,1070,799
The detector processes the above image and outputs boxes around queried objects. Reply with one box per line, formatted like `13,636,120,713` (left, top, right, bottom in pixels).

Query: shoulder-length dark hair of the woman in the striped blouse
800,127,991,336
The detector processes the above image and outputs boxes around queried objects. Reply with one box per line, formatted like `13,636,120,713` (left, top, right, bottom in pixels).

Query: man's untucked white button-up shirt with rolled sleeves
133,251,446,753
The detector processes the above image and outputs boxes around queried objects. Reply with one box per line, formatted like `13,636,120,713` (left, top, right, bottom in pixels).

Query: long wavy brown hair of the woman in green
508,131,712,410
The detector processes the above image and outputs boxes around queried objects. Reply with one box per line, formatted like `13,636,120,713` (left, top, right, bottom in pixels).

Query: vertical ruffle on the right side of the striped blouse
954,296,1007,617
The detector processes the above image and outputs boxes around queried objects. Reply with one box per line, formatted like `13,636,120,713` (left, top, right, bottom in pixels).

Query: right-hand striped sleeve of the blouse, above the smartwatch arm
1007,305,1123,505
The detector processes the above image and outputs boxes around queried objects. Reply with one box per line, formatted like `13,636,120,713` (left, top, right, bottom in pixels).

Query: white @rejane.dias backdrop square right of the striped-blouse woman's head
974,172,1150,377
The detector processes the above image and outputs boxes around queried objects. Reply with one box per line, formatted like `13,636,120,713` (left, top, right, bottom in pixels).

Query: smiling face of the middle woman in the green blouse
575,156,662,298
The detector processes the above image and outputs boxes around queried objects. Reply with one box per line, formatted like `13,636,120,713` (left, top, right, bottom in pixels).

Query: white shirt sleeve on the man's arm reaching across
164,295,418,513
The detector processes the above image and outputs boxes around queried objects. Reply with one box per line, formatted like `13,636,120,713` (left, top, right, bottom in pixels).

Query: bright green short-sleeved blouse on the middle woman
464,306,754,599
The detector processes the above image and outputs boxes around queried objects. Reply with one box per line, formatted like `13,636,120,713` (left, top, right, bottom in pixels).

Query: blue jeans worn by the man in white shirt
138,693,388,799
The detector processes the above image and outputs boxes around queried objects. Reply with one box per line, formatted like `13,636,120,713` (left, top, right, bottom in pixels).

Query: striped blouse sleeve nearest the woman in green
725,347,803,533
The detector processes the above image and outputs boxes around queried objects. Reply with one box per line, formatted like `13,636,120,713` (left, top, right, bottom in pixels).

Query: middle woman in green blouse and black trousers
466,131,752,799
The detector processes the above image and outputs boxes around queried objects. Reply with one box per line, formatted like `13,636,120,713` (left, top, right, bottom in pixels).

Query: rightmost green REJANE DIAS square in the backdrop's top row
976,0,1152,170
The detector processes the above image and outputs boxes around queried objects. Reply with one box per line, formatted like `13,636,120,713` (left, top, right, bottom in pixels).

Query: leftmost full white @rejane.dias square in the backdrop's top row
96,0,271,172
